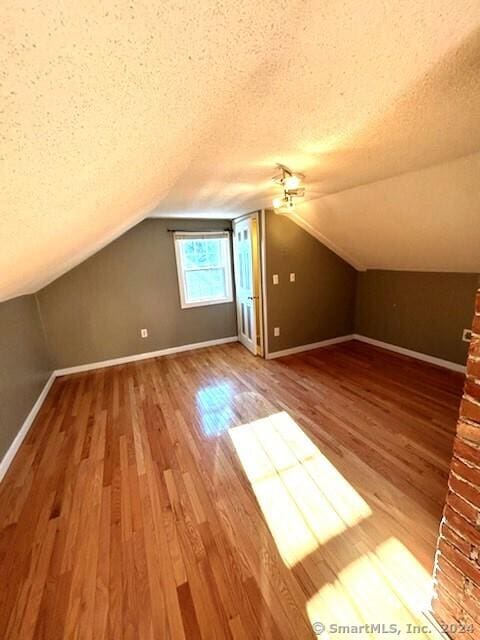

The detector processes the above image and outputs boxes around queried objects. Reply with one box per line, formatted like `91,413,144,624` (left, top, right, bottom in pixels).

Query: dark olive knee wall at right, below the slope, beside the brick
355,271,478,364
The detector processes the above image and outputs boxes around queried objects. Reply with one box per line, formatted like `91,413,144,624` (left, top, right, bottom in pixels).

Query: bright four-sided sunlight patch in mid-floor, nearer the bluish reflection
229,412,371,567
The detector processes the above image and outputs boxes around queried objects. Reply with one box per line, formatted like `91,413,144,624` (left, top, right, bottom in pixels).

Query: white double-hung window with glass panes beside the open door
175,232,233,309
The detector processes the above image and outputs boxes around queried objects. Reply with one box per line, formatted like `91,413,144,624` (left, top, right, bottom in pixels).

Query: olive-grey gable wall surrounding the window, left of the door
37,219,237,368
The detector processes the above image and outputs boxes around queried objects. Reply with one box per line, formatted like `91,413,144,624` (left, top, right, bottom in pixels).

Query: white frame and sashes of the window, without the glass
173,231,233,309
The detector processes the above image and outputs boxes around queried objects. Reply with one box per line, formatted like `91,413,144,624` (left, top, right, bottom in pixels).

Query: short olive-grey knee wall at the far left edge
0,295,52,460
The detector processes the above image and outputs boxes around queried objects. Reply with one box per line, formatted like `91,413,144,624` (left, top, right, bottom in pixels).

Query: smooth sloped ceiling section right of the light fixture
295,153,480,273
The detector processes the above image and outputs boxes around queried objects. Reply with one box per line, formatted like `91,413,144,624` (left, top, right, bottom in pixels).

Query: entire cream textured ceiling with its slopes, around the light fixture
0,0,480,299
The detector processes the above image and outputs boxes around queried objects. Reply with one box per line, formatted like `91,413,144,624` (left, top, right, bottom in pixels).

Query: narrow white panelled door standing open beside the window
233,217,259,355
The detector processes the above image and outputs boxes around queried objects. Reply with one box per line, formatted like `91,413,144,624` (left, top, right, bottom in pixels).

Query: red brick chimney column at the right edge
432,289,480,640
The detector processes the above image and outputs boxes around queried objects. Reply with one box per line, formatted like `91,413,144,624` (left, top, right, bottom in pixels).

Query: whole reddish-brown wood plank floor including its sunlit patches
0,342,463,640
